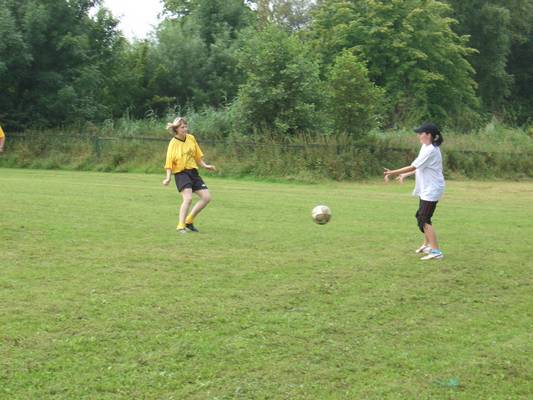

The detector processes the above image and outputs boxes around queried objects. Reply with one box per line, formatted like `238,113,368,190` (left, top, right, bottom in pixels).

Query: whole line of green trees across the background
0,0,533,136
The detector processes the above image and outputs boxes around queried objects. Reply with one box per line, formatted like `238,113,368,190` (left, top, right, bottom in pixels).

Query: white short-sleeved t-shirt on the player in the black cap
411,144,444,201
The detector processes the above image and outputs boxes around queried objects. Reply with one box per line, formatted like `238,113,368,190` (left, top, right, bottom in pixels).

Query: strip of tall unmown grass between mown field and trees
0,116,533,181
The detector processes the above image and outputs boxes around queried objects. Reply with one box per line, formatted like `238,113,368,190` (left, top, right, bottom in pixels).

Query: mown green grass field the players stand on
0,169,533,400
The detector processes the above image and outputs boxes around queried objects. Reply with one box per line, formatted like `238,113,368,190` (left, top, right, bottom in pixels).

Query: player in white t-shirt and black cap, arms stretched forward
383,123,445,260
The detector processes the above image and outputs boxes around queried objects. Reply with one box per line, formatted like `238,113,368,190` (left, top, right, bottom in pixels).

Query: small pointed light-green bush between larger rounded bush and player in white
326,50,383,137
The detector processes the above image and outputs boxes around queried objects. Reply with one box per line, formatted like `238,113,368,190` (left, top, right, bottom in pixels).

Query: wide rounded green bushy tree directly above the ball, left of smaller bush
234,26,322,134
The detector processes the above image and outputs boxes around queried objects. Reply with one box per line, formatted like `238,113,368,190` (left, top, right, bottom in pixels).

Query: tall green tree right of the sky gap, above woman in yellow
151,0,254,108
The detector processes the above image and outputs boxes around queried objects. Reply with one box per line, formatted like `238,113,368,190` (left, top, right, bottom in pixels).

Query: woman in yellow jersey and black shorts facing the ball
163,117,216,233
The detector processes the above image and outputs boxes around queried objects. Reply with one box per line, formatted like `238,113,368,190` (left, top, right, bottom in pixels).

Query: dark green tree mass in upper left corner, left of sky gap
0,0,123,128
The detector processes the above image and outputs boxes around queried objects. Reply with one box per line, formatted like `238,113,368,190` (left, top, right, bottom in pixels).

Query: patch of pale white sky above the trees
104,0,163,40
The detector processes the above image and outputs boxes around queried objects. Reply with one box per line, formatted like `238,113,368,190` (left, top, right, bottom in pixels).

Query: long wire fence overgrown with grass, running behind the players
0,134,533,180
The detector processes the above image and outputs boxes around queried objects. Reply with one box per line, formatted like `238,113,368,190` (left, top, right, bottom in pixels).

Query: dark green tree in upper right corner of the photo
447,0,533,119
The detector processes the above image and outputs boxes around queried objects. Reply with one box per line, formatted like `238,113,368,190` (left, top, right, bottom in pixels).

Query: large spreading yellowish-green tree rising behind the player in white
311,0,477,125
